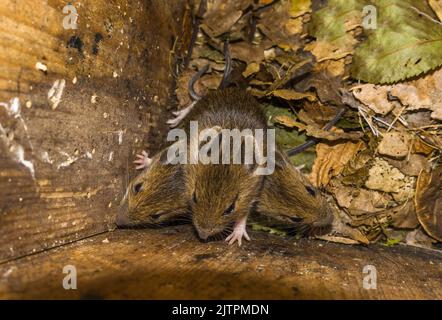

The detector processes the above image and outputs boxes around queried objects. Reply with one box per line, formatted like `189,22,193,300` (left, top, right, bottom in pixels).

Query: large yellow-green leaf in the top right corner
351,0,442,83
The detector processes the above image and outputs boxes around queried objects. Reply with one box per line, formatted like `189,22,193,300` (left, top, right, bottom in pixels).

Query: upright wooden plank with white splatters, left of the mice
0,0,188,262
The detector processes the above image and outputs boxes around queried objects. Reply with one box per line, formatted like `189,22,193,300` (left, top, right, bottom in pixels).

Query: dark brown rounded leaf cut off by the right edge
415,166,442,241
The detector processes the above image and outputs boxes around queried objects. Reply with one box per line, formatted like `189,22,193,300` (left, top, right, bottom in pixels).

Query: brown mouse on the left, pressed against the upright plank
116,148,188,227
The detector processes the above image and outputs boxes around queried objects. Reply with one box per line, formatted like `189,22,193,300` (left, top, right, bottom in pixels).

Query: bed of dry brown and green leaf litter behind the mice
176,0,442,247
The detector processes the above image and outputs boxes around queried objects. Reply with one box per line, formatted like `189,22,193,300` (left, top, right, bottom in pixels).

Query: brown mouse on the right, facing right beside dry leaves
256,151,333,233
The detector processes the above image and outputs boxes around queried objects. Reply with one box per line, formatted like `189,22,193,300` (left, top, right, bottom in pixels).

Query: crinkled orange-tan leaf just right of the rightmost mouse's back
309,142,364,187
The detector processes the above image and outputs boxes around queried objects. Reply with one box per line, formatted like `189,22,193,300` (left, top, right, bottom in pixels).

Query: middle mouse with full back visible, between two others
179,88,267,245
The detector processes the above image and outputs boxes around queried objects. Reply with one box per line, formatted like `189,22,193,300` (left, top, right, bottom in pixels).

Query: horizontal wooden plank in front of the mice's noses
0,225,442,299
